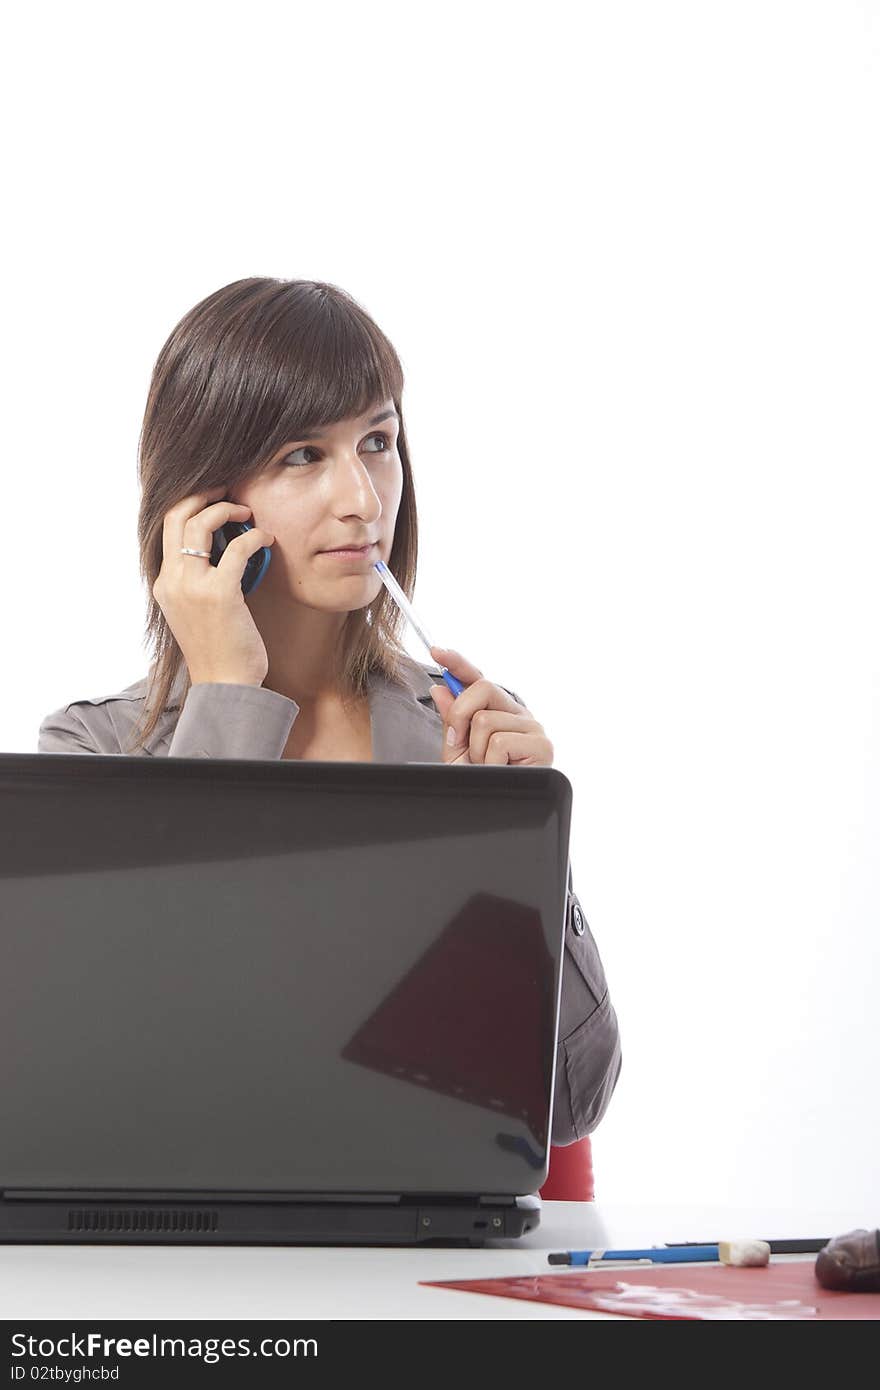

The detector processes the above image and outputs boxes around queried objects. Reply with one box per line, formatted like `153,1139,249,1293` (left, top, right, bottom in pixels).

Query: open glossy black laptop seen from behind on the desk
0,753,571,1245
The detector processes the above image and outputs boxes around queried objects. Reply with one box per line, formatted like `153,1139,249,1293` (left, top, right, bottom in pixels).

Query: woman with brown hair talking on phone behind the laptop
38,278,620,1162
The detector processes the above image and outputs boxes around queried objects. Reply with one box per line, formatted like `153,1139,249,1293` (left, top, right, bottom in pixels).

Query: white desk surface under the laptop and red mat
0,1202,856,1322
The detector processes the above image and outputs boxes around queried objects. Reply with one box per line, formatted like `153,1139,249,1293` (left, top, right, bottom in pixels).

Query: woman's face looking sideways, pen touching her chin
231,400,403,612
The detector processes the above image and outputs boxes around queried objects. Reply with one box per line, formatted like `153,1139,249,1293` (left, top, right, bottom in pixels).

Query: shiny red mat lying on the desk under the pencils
420,1258,880,1321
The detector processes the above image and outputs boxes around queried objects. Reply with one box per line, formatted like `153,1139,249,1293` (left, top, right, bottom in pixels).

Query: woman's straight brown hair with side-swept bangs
127,277,418,752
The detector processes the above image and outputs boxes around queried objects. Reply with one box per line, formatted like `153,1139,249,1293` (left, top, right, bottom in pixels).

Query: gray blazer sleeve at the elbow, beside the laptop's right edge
503,685,621,1145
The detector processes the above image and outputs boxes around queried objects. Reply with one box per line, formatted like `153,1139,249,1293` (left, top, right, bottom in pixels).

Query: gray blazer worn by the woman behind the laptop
38,657,620,1144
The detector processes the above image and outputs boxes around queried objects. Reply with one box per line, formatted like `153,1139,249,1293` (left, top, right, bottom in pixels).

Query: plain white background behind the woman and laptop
0,0,880,1217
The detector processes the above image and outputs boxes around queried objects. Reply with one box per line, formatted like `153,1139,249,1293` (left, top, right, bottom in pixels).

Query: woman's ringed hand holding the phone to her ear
153,487,275,685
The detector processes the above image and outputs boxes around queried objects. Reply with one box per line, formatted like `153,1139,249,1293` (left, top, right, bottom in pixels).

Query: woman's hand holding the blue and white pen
431,646,553,767
